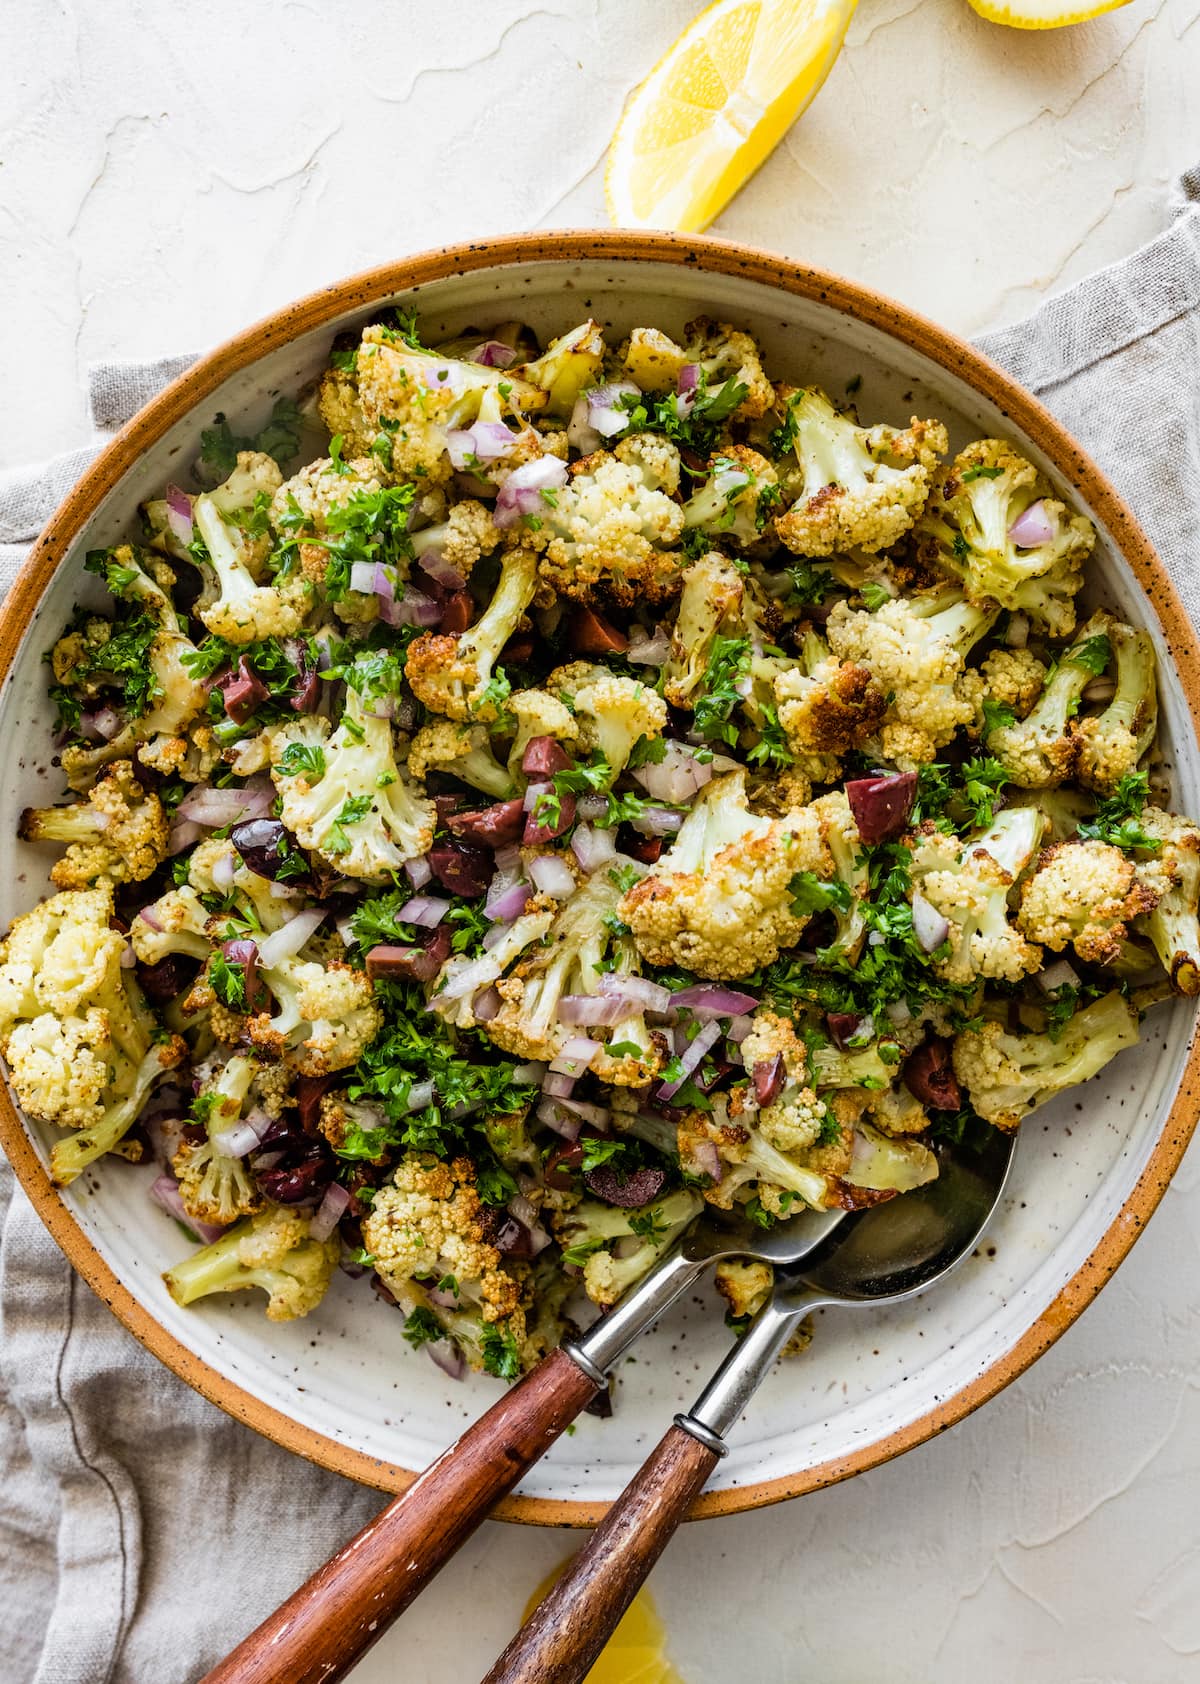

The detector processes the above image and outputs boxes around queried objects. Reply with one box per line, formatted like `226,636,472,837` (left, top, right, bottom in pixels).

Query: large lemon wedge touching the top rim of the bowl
604,0,857,232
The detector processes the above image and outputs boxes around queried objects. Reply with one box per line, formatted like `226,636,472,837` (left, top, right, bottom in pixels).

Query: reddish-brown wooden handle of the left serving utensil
200,1351,597,1684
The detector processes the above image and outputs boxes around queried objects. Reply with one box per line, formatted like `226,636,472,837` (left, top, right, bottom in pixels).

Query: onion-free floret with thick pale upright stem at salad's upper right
776,387,948,556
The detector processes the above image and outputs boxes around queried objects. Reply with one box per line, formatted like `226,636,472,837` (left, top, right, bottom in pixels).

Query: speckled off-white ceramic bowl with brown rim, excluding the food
0,237,1200,1522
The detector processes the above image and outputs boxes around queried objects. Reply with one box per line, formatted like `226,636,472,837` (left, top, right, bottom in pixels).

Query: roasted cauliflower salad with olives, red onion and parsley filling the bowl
0,310,1200,1381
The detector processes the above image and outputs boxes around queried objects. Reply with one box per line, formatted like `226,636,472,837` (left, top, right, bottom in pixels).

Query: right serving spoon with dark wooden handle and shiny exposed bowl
483,1132,1015,1684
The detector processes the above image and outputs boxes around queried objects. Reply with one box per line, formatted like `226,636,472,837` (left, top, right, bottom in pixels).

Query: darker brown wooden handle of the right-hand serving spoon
483,1426,719,1684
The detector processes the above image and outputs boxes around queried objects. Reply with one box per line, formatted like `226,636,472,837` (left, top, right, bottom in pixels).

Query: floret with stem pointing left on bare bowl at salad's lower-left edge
163,1204,342,1322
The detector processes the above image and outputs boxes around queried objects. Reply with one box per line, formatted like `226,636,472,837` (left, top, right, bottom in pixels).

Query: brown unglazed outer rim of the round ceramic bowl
0,229,1200,1526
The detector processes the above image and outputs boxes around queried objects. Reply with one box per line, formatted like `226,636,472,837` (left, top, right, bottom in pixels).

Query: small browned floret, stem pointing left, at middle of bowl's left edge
17,759,170,889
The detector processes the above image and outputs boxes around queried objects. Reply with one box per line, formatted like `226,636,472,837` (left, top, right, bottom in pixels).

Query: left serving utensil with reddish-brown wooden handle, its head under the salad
200,1194,841,1684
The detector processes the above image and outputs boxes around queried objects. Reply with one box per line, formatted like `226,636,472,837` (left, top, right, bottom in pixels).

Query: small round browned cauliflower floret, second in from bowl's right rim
1017,840,1160,965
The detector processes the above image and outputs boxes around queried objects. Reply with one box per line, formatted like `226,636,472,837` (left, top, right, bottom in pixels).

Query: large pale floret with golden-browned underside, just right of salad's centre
619,771,833,978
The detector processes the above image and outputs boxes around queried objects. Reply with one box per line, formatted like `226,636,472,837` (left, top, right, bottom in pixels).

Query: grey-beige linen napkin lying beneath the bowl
0,165,1200,1684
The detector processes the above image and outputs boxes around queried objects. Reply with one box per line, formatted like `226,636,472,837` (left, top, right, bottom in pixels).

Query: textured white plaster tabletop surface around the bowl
0,0,1200,1684
